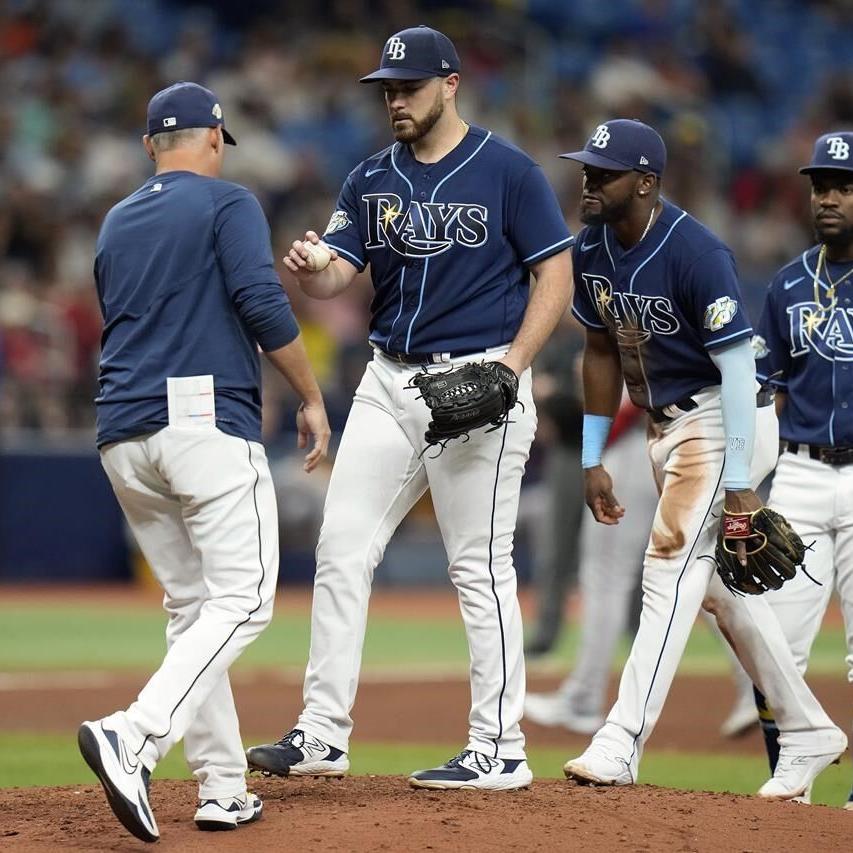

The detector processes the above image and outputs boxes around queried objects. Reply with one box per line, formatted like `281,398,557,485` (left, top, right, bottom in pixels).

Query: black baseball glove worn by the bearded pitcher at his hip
409,361,518,449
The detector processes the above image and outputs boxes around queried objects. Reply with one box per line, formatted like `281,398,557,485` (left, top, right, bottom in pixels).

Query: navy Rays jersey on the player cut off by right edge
754,246,853,447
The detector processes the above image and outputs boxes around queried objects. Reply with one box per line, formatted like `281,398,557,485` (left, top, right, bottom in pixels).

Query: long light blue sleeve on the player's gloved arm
708,338,755,490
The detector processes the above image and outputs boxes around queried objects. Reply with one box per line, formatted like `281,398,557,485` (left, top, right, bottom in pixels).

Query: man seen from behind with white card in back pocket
78,83,329,841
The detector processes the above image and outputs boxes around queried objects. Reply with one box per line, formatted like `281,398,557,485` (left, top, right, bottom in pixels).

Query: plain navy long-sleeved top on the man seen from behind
95,171,299,446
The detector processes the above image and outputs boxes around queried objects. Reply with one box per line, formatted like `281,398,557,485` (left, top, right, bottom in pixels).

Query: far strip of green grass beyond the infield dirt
0,603,845,675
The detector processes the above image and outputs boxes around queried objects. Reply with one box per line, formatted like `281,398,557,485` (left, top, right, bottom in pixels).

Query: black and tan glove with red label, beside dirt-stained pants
714,506,806,595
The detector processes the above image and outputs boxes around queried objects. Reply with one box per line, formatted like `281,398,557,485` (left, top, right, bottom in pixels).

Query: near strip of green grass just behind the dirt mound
0,732,851,805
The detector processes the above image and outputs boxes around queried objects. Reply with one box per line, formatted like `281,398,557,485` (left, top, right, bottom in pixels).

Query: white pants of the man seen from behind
101,426,278,799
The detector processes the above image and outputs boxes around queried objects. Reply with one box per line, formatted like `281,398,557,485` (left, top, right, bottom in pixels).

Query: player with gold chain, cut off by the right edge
754,131,853,809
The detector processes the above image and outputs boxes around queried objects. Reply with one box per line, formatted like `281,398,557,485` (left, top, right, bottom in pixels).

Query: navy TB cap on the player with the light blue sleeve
560,118,666,177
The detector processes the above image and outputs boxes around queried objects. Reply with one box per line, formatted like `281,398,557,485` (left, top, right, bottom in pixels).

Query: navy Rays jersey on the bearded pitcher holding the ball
323,127,572,353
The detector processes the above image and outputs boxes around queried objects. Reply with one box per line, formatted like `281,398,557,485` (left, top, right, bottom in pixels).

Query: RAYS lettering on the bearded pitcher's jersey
361,193,489,258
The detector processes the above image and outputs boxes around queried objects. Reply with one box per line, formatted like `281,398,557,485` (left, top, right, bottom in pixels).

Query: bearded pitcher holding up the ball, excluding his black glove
248,26,572,789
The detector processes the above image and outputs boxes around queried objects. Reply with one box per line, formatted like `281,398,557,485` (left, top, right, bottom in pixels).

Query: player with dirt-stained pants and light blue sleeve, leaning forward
562,119,847,799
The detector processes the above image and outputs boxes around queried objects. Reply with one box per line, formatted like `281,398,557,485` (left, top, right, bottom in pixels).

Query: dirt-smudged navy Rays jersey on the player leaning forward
572,201,752,408
